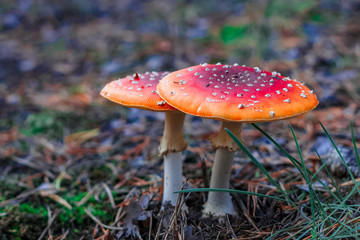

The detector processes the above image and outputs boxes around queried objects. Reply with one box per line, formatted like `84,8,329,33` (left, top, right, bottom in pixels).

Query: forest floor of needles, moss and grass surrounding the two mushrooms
0,0,360,240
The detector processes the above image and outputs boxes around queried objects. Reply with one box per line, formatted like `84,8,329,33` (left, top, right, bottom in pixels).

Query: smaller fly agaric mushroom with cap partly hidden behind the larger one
100,72,186,206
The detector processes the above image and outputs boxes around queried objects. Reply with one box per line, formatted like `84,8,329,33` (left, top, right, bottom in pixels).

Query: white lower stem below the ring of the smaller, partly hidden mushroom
163,152,183,206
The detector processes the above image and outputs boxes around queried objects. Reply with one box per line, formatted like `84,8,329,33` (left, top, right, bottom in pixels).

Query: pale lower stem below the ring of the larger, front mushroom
203,148,235,217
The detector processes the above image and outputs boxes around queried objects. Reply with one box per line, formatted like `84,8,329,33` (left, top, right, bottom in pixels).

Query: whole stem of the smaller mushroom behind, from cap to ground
159,111,186,206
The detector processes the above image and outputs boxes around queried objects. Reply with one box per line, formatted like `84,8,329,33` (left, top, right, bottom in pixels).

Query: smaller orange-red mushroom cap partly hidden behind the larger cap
100,72,175,111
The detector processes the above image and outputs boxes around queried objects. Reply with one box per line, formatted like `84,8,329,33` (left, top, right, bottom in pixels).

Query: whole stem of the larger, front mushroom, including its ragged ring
203,121,242,216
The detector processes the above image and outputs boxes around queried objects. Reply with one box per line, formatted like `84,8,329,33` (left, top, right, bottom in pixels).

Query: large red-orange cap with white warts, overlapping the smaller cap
157,63,318,122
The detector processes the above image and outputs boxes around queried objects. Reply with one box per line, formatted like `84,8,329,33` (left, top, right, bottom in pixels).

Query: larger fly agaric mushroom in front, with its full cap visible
157,63,318,216
